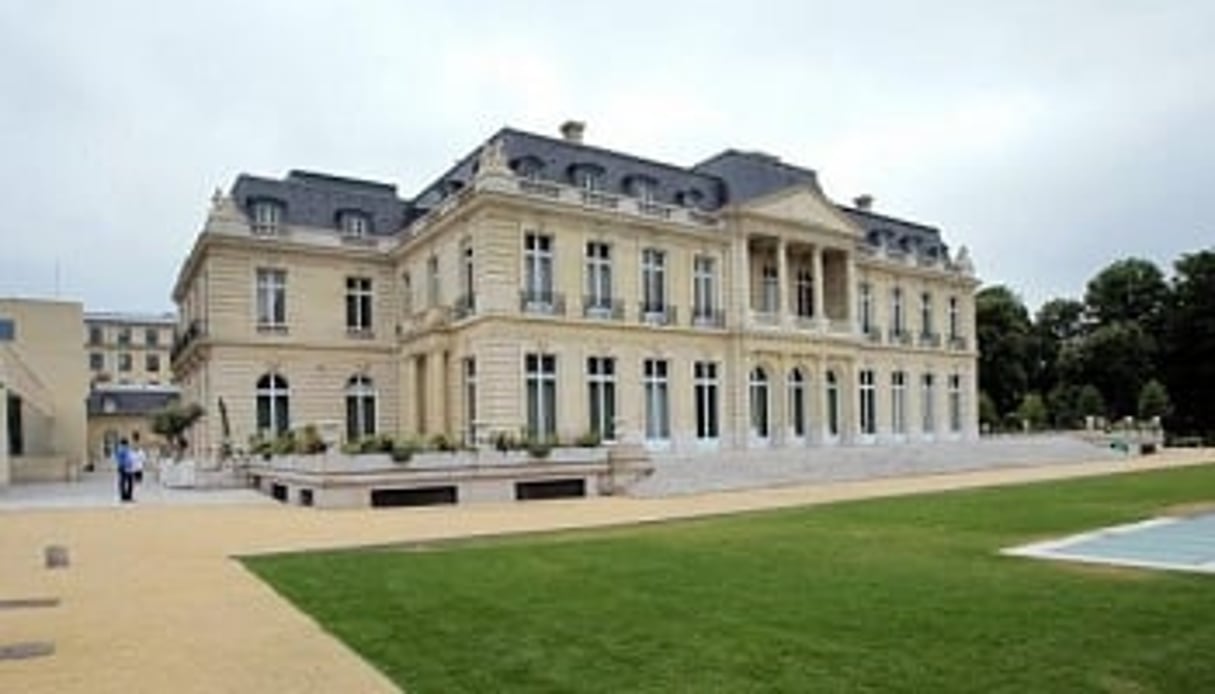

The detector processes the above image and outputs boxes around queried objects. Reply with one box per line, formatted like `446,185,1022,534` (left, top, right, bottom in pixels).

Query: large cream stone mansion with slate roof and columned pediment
171,123,978,456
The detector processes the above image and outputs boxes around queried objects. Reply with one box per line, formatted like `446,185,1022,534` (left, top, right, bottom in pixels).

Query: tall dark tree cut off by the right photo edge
1163,248,1215,434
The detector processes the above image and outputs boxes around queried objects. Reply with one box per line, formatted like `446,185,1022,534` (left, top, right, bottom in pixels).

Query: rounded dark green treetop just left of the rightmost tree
1084,258,1169,332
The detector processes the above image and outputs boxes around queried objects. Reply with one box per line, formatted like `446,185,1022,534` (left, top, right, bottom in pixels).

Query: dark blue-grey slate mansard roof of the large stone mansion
223,128,948,258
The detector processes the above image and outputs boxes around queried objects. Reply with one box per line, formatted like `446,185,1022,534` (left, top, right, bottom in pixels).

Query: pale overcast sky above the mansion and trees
0,0,1215,311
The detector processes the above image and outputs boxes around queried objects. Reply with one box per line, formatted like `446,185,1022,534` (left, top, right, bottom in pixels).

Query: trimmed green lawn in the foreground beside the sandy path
247,468,1215,694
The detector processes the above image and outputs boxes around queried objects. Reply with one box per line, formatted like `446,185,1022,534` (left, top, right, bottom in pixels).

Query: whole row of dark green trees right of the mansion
976,248,1215,440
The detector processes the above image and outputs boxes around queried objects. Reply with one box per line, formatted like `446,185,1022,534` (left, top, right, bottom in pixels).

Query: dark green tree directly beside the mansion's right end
974,286,1032,414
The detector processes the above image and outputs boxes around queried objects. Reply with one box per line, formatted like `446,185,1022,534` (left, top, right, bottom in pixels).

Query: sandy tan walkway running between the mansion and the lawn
0,450,1215,693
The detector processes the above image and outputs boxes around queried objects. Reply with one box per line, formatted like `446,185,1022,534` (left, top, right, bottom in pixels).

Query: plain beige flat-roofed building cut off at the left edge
0,299,89,486
